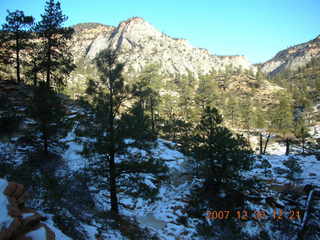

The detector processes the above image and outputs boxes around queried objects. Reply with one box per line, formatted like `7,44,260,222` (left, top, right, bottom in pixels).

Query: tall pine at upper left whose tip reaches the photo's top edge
35,0,74,87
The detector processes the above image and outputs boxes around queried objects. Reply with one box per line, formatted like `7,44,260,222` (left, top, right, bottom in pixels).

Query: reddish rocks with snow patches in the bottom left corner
0,179,55,240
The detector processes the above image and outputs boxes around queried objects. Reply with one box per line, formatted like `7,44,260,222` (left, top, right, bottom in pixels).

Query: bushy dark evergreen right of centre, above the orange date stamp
193,107,253,188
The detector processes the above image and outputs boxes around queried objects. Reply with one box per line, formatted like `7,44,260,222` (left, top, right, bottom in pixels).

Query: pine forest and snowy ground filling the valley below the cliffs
0,0,320,240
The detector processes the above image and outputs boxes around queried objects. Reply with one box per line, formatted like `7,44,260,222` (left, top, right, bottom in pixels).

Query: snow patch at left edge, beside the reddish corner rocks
0,179,13,230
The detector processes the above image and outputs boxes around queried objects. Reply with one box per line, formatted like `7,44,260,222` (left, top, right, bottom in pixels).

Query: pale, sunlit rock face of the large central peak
71,17,256,76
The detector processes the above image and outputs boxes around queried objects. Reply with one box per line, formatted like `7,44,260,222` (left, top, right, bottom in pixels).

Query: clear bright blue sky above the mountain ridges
0,0,320,63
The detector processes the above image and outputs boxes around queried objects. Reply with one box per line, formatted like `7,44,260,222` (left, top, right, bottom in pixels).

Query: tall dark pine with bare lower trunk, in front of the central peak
83,50,165,216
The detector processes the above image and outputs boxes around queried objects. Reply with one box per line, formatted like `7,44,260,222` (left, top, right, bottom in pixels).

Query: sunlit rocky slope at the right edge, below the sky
261,36,320,75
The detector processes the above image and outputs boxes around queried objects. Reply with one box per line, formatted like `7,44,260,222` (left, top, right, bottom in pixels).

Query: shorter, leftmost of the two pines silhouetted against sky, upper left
2,10,34,82
